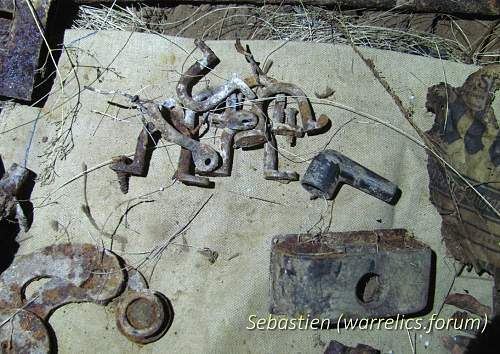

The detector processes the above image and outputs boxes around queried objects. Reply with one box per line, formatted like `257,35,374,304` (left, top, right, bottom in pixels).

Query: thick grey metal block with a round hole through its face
270,229,432,323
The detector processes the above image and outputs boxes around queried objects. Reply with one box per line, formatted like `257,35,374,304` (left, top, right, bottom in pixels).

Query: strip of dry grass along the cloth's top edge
74,5,500,65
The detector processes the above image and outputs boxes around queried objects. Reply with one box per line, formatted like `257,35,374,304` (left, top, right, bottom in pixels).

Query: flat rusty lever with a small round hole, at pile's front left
142,102,219,172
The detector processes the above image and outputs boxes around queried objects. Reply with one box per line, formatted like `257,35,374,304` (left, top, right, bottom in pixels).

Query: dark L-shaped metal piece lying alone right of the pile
300,150,401,204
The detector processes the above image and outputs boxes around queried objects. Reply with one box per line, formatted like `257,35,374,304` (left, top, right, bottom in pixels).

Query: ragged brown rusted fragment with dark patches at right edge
426,64,500,274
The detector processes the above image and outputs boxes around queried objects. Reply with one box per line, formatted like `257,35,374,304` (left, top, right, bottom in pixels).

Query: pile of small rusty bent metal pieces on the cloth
107,40,330,193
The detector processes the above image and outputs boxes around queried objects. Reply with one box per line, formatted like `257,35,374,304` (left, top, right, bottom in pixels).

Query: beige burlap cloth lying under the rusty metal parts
0,31,491,353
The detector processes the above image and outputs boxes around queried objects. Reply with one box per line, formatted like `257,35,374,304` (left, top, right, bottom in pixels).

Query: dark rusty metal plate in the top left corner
0,0,52,101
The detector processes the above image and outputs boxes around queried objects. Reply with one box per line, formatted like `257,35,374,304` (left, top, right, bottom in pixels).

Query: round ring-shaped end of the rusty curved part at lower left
116,270,174,344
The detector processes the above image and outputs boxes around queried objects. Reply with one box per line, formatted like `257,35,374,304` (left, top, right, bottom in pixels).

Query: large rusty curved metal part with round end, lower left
0,244,173,353
